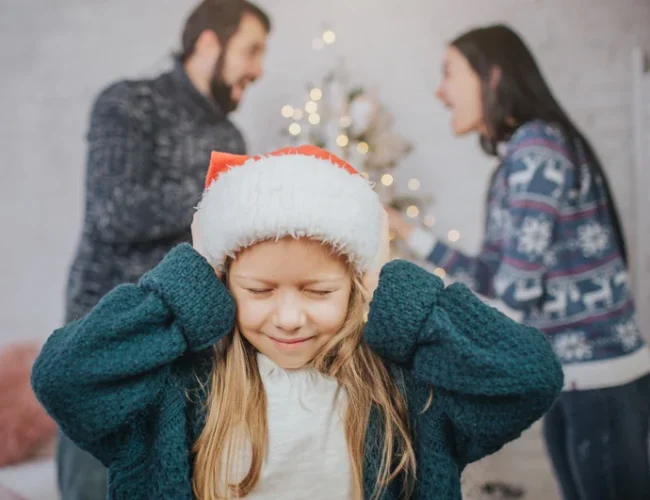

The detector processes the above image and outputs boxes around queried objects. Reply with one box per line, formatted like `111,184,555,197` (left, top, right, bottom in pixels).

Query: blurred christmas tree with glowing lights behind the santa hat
281,29,435,242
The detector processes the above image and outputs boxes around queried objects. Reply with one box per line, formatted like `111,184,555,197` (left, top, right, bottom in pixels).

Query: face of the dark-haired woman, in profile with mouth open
436,46,485,135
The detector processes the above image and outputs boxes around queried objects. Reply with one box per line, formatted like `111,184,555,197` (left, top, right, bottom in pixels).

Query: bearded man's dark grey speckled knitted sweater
66,62,245,321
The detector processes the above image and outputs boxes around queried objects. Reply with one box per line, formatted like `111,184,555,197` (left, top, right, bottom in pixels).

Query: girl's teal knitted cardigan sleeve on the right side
365,261,564,466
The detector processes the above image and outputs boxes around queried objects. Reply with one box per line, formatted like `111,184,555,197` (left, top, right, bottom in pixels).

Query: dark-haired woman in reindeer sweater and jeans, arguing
389,25,650,500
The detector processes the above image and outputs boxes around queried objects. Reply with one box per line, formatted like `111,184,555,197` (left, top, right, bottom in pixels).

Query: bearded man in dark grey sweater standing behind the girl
57,0,271,500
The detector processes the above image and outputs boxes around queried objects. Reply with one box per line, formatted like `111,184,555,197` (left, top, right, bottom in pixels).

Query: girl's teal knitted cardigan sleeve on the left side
32,244,235,464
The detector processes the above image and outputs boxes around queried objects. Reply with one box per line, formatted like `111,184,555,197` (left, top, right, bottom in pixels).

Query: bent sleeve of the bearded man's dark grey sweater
86,82,202,242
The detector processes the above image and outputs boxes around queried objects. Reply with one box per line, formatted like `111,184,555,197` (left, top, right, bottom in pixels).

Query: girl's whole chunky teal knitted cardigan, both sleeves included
32,244,563,500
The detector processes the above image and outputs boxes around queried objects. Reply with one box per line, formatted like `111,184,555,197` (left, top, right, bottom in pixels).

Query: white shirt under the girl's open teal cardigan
231,354,352,500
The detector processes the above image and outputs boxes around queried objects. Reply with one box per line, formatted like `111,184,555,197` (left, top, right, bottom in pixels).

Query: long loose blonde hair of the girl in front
192,264,415,500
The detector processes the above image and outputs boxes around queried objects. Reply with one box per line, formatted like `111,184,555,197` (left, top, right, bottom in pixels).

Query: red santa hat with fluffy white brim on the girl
198,146,383,273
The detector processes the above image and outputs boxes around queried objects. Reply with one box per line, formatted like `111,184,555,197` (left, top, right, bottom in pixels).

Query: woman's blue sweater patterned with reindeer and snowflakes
412,121,650,389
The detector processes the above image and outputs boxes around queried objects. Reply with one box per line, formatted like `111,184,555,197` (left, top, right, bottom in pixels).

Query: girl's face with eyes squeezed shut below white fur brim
228,238,352,369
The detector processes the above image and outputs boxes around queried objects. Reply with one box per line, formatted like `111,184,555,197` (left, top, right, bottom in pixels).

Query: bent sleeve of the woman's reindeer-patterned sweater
428,123,574,312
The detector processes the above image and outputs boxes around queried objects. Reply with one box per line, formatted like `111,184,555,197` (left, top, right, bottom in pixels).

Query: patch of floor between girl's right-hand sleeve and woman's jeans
462,423,560,500
